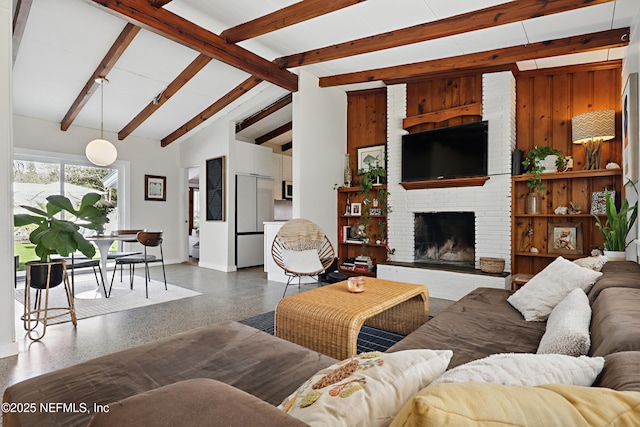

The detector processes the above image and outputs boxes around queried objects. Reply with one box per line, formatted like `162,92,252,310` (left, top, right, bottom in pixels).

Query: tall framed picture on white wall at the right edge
622,73,638,182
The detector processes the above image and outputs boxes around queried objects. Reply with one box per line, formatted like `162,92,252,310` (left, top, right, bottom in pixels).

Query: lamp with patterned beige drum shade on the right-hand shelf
571,110,616,170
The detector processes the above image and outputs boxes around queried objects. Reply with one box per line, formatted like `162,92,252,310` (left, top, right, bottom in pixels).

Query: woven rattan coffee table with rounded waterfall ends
275,277,429,359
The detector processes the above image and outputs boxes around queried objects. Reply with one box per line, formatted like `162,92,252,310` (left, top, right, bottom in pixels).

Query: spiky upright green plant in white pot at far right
594,187,638,261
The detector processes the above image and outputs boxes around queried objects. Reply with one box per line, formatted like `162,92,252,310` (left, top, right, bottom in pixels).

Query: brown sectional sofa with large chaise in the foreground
3,262,640,427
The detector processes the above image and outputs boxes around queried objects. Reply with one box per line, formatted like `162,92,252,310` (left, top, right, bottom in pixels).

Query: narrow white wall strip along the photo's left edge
0,0,18,358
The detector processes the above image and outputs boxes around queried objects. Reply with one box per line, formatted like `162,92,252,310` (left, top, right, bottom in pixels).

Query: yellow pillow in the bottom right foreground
391,383,640,427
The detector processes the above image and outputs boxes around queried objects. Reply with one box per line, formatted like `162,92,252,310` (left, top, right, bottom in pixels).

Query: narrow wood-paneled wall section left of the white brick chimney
347,88,387,174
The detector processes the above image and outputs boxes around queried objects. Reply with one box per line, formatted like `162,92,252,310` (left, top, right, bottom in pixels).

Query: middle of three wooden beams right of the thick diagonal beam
274,0,612,68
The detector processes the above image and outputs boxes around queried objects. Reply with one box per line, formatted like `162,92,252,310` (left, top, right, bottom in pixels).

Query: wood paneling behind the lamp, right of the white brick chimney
516,61,622,170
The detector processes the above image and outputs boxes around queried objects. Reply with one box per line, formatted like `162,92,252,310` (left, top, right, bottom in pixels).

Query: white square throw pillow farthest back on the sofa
507,257,602,321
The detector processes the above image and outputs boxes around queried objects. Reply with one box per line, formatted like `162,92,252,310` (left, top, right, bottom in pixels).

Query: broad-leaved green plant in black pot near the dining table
14,193,109,287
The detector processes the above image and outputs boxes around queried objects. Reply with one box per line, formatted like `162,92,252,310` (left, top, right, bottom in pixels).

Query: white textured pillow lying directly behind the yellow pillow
433,353,604,386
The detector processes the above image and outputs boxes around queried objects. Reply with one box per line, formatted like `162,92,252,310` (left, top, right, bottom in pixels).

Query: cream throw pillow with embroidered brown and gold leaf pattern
278,350,453,427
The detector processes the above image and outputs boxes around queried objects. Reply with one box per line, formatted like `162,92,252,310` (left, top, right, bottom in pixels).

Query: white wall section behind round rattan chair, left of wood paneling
293,70,347,242
